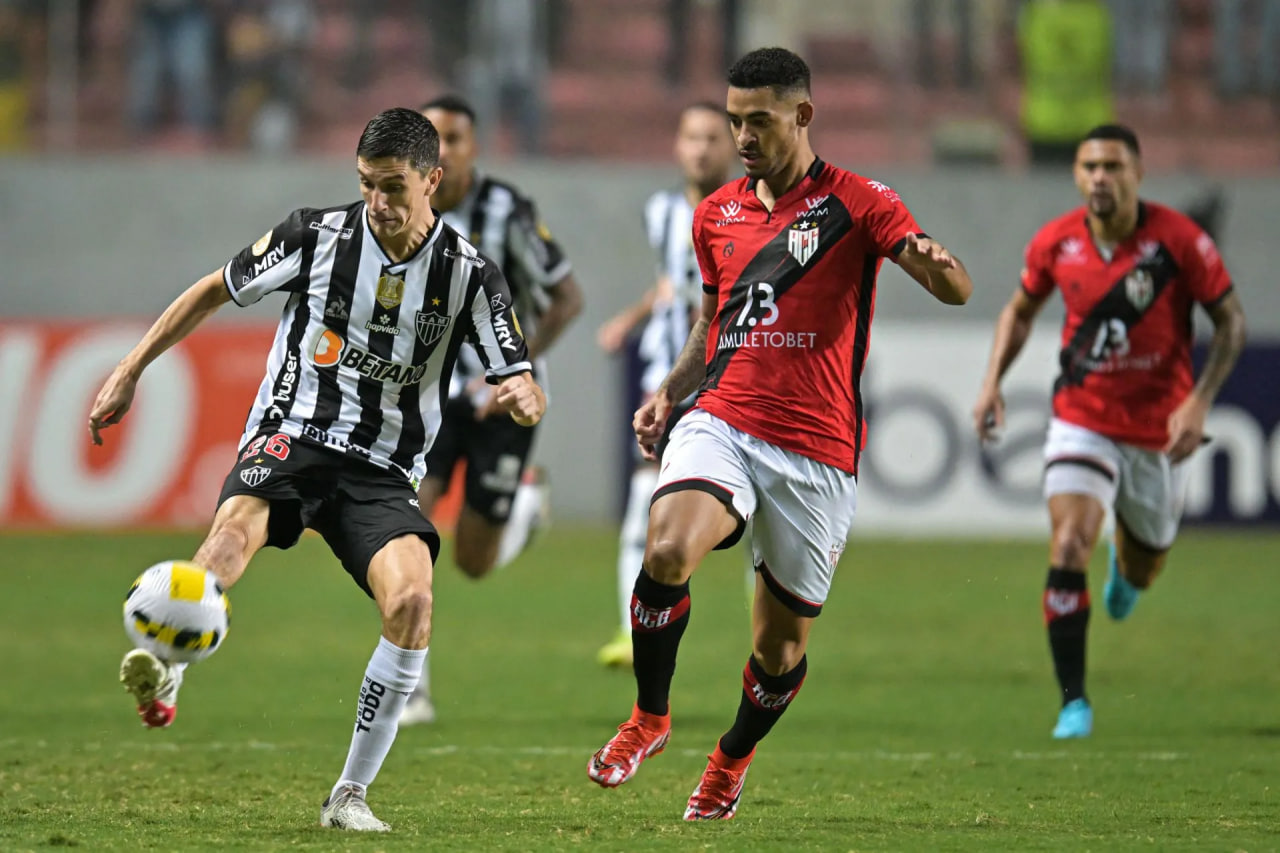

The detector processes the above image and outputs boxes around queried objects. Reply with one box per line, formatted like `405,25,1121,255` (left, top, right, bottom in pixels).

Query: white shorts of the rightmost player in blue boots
1044,418,1188,551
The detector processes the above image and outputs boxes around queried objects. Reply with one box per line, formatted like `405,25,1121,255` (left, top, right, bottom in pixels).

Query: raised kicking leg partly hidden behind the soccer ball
120,494,270,729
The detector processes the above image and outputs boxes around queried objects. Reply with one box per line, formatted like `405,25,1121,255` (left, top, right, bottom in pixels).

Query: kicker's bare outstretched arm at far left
88,269,232,444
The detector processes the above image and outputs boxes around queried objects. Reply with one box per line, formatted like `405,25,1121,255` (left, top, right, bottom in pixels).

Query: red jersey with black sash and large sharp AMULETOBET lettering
694,160,920,474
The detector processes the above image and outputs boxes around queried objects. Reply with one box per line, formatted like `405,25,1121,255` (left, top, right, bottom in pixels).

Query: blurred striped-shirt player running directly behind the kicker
401,95,582,725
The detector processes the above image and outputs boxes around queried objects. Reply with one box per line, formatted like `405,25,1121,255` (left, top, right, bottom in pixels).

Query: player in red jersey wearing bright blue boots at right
974,124,1244,738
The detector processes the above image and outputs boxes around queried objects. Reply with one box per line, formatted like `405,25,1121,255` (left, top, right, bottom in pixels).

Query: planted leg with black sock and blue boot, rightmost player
1043,493,1106,739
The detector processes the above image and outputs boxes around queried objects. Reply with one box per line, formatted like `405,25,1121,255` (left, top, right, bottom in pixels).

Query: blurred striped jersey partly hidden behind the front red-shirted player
640,190,703,393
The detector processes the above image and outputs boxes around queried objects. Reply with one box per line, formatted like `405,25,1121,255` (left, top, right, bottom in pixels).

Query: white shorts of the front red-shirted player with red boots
654,409,858,616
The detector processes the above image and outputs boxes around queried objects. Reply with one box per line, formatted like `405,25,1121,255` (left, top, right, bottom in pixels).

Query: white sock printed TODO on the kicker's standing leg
330,637,426,797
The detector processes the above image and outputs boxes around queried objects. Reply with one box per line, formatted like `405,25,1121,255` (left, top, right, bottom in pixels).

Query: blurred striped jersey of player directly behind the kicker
443,173,571,397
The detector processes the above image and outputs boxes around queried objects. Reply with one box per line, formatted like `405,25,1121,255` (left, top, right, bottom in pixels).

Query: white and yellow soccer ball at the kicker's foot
124,560,232,663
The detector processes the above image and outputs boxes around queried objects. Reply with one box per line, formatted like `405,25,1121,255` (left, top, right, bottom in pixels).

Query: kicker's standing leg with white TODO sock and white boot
320,534,431,833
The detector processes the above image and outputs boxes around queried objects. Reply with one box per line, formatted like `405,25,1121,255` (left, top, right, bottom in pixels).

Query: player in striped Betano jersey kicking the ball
88,109,547,831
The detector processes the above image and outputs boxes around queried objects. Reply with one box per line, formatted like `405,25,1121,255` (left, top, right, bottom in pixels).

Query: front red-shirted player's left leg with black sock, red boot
586,481,742,788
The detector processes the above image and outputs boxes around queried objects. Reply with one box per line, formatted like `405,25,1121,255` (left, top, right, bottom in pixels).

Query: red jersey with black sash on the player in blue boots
1021,202,1231,450
